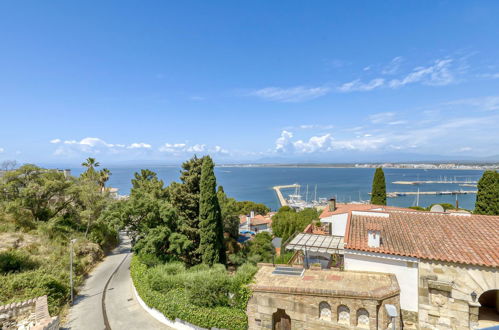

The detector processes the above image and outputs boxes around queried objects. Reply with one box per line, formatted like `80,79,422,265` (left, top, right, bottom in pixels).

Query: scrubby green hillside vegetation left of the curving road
0,159,117,313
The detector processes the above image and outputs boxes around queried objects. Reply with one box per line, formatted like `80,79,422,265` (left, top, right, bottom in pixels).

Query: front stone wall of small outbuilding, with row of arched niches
247,292,400,329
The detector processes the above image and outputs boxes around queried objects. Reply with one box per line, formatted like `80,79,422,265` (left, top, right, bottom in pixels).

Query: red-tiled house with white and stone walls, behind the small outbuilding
344,208,499,329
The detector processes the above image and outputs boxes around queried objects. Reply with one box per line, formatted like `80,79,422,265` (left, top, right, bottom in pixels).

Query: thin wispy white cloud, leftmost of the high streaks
250,86,330,102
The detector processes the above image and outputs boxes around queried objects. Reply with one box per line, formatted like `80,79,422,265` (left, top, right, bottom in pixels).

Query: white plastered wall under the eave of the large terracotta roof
344,250,419,312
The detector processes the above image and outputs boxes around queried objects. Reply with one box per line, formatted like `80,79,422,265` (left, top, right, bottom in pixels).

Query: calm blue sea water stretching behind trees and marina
64,166,483,210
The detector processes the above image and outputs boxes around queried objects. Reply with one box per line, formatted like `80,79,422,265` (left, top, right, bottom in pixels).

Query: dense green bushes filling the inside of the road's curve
130,256,252,329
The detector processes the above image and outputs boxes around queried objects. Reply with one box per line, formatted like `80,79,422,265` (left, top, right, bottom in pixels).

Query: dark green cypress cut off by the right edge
474,170,499,215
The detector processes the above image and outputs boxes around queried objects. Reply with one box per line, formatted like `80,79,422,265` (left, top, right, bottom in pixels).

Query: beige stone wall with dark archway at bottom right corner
419,260,499,330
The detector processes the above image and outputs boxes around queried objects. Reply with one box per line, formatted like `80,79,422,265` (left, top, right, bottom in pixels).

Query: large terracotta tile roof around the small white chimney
345,211,499,267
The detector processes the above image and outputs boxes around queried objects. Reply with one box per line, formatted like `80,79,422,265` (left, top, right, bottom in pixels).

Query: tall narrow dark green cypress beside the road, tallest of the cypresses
199,156,226,265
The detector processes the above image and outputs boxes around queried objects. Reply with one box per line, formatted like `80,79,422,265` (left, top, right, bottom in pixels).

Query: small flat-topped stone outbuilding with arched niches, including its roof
247,264,399,329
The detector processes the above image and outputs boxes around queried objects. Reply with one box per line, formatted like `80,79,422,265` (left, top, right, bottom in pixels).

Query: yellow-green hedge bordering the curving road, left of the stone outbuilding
130,256,255,329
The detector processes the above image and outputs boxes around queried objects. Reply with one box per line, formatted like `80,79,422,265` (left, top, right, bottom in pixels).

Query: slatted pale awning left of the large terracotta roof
286,233,343,254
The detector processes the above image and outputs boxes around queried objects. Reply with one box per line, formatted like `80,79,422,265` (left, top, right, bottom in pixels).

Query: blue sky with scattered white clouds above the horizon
0,1,499,164
